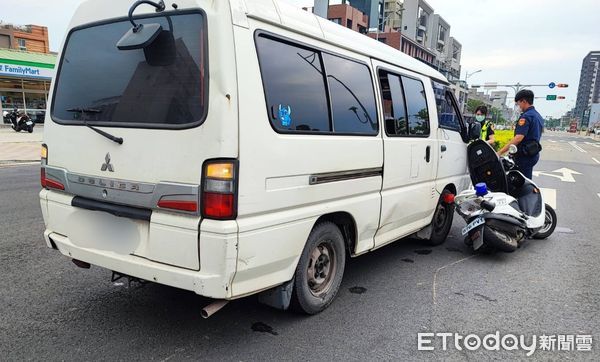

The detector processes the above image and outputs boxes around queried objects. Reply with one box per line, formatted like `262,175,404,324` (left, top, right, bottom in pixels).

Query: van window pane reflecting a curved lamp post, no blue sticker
323,53,379,135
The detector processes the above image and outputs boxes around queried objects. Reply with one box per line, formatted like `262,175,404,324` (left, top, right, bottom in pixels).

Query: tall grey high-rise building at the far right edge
574,51,600,126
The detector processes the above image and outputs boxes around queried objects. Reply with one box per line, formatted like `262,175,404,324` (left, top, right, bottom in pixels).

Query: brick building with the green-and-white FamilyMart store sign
0,24,56,122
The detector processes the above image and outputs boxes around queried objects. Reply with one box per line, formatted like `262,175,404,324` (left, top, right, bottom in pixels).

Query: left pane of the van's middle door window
379,70,408,136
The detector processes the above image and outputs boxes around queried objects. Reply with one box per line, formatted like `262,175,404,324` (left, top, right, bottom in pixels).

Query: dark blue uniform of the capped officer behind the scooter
515,106,544,179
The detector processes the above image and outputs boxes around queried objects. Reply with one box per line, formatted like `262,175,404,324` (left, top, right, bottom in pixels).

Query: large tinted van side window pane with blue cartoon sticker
256,36,331,132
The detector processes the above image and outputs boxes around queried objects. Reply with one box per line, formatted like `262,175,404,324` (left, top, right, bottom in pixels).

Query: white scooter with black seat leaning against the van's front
454,140,557,252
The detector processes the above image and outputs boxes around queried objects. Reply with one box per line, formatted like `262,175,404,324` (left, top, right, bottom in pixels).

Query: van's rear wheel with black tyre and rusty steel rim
291,221,346,314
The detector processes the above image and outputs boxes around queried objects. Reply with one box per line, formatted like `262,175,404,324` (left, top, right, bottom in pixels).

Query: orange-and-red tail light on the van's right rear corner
201,160,238,220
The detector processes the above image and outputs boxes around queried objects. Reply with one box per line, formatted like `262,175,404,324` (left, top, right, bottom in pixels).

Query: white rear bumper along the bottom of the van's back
40,190,237,299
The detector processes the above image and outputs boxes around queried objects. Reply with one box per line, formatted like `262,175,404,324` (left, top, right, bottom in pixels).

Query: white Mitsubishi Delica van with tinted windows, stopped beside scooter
40,0,470,315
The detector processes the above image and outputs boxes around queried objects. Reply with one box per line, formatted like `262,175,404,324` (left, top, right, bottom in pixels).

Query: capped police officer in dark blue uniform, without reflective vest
498,89,544,179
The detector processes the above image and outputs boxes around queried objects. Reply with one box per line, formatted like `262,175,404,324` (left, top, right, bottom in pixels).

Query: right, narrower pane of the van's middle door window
402,76,430,137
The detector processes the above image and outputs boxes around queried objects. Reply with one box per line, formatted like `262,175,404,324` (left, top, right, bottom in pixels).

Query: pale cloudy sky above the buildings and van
0,0,600,117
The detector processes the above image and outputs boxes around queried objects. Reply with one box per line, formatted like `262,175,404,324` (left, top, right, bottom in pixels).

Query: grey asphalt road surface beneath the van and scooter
0,133,600,361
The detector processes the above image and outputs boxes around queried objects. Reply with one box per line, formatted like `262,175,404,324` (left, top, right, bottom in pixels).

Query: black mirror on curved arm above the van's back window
117,0,165,50
